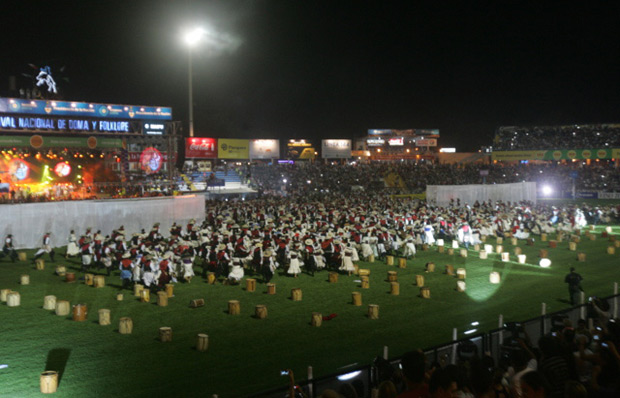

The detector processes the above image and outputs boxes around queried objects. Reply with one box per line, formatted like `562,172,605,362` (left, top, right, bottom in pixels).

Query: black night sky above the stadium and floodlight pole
0,0,620,151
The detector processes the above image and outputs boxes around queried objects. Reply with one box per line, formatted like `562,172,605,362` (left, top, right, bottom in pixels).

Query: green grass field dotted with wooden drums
0,227,620,397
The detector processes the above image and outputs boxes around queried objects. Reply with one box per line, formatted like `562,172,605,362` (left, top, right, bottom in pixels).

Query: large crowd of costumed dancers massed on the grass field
17,195,618,289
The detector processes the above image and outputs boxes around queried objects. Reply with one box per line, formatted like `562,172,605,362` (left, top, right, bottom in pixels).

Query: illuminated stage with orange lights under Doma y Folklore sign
0,98,178,201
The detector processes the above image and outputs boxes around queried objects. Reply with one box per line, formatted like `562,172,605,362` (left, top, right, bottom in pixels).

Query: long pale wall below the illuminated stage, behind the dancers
0,195,205,249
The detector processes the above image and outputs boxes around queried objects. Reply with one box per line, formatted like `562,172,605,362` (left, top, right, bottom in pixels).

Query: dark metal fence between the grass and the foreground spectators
251,290,620,398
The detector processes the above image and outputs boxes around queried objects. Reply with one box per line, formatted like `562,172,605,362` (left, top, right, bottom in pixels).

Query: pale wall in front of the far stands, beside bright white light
426,182,536,206
